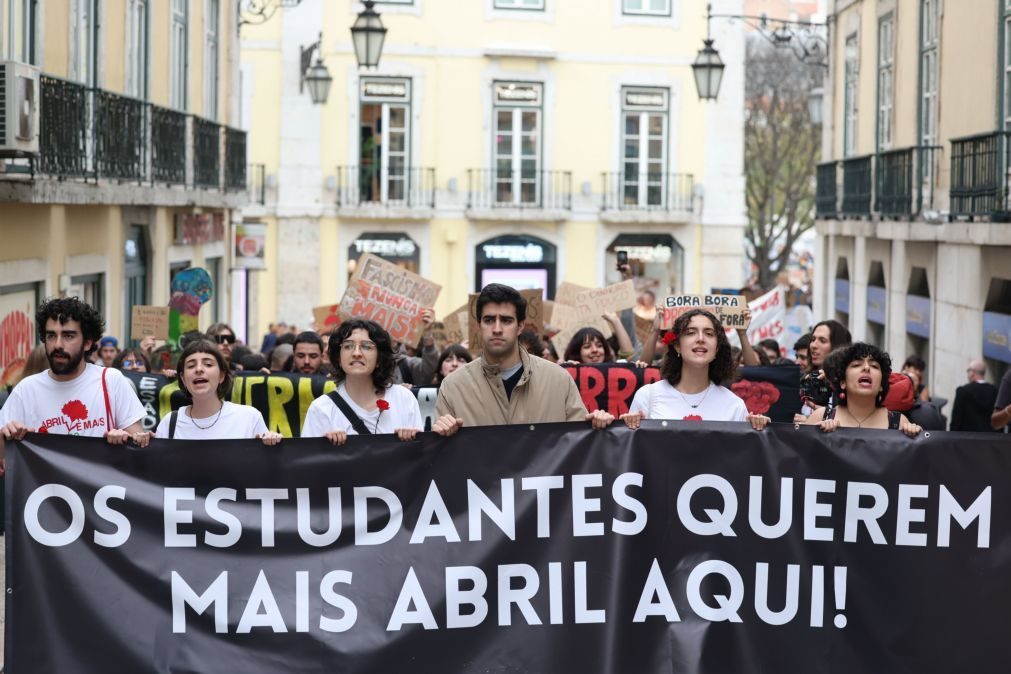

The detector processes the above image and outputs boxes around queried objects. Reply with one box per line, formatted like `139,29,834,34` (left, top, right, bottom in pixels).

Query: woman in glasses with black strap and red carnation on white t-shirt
301,318,425,445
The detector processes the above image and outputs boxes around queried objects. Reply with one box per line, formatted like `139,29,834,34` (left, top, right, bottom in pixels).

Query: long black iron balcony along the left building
0,75,246,208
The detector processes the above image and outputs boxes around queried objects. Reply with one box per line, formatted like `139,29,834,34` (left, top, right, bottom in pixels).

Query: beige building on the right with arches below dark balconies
815,0,1011,411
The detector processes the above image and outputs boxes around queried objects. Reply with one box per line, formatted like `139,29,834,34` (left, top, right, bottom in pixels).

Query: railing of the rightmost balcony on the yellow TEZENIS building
603,172,695,213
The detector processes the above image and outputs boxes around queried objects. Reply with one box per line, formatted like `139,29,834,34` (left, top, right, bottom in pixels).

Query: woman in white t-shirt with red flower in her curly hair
621,309,769,430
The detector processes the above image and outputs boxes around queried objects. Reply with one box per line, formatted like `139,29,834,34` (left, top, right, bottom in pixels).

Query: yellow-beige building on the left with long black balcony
0,0,247,377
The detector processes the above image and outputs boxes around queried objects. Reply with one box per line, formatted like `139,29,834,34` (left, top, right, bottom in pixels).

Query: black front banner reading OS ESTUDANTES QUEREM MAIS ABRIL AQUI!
6,430,1011,674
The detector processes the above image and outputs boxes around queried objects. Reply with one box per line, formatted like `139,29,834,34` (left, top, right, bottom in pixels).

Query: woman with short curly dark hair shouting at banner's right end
808,342,922,438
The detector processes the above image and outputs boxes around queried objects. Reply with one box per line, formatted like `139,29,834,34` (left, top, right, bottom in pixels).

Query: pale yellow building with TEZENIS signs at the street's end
241,0,745,332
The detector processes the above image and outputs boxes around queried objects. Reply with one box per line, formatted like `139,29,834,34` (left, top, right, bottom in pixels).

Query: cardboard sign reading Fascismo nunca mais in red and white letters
339,253,442,344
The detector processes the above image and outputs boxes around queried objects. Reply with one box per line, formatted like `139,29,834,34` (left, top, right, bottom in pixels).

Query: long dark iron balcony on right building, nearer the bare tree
815,146,943,219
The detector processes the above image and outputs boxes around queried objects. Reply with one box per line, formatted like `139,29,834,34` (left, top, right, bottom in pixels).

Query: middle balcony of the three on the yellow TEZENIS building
467,169,572,221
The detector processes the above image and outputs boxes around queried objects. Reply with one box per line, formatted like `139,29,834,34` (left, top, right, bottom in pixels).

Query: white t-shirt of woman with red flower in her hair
629,379,748,421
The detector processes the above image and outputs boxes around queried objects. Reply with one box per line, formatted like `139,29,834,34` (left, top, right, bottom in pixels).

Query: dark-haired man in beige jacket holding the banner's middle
432,283,615,436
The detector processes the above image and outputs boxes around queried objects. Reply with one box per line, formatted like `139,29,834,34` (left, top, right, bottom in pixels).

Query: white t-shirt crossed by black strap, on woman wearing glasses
301,382,425,438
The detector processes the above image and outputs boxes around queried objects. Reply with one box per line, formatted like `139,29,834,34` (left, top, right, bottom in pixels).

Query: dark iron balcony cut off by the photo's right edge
950,131,1011,221
